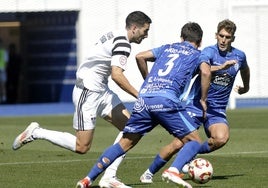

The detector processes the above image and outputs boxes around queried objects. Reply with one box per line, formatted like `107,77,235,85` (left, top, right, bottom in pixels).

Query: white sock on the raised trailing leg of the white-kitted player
33,128,76,152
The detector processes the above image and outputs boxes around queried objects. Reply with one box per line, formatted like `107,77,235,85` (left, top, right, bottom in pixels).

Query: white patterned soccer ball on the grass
188,158,213,184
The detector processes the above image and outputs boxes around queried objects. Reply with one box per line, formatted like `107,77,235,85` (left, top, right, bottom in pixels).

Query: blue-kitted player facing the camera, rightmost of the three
140,19,250,183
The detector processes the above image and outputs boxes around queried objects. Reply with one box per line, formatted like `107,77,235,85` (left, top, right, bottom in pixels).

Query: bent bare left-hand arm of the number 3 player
136,50,155,79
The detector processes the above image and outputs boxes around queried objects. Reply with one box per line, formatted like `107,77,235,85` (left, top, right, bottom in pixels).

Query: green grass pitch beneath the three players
0,109,268,188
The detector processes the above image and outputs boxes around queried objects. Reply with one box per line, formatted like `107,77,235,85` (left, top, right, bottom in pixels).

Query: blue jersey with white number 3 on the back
139,42,200,102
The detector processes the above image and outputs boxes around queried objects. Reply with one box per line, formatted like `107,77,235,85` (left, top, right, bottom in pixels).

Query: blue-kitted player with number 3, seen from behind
76,22,211,188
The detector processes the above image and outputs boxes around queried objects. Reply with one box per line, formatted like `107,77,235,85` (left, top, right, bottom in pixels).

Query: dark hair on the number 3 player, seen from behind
181,22,203,46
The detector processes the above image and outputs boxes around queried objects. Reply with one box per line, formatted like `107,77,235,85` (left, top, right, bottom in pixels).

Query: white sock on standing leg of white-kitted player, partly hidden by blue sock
102,131,126,179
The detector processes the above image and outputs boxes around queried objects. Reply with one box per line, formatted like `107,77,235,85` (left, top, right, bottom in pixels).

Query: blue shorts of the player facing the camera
186,101,229,135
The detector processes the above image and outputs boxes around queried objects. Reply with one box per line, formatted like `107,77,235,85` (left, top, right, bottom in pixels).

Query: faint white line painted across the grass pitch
0,151,268,166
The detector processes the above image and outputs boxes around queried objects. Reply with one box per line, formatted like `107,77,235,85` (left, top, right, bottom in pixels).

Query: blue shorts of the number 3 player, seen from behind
123,97,196,138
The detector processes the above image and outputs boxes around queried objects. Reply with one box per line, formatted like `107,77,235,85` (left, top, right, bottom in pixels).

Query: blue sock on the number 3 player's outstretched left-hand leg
87,143,125,181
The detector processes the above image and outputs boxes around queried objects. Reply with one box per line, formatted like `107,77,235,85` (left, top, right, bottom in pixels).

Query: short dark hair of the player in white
126,11,152,28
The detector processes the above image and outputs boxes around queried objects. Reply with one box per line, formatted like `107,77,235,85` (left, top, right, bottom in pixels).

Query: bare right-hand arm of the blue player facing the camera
234,67,250,95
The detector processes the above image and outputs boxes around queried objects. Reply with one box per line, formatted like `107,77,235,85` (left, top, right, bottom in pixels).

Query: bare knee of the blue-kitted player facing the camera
208,123,230,139
